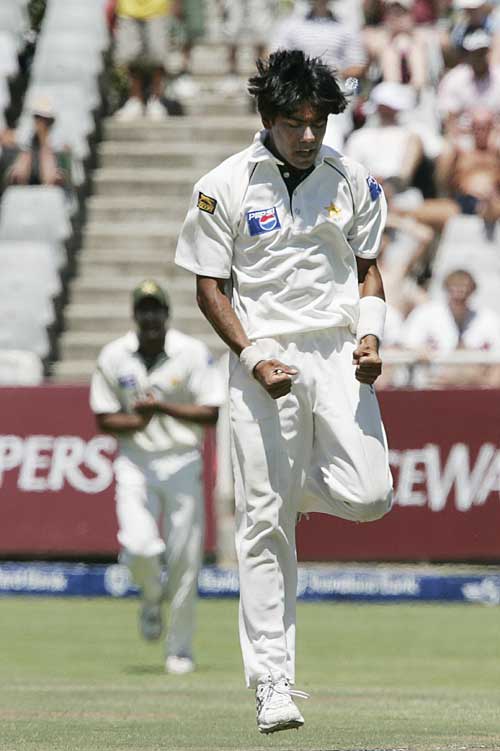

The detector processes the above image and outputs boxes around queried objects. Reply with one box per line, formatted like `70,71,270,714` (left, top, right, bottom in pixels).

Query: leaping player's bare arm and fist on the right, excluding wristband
353,257,385,385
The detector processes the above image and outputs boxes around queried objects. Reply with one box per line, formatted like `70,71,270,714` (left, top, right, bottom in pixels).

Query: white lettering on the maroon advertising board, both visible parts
0,435,500,512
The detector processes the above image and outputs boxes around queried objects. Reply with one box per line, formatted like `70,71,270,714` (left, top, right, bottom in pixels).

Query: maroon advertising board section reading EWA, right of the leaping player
298,389,500,561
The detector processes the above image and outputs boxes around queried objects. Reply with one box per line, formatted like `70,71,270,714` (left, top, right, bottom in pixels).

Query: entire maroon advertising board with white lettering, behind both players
0,386,500,561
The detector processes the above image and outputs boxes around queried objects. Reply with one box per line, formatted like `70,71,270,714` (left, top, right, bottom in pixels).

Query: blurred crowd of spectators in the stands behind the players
0,0,500,386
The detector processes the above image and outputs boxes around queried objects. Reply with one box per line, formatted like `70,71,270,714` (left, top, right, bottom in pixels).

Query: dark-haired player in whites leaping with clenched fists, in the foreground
176,50,392,733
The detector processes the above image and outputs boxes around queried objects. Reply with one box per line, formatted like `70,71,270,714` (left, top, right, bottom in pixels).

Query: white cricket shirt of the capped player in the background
90,329,226,462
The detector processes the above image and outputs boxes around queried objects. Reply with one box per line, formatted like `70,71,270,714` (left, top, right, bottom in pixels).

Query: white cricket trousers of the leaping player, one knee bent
229,328,392,687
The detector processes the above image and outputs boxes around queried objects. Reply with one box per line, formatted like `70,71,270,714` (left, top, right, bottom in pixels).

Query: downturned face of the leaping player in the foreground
263,104,326,170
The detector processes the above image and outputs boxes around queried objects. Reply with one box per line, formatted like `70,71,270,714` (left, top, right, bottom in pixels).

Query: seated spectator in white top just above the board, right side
401,269,500,386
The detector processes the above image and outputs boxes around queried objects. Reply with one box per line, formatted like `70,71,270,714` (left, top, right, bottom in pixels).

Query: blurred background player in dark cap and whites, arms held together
90,281,225,673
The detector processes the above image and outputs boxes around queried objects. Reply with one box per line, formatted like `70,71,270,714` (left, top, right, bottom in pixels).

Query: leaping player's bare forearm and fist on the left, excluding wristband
196,276,297,399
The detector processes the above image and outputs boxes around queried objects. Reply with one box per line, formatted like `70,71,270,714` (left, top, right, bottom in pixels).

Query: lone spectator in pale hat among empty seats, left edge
4,97,70,188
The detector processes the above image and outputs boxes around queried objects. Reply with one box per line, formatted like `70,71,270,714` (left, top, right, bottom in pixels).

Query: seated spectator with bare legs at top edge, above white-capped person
363,0,430,91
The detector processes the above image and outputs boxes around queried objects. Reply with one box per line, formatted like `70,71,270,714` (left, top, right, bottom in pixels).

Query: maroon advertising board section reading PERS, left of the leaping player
0,386,215,557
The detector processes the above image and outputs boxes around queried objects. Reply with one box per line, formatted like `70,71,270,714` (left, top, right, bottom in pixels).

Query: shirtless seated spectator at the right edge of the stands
396,105,500,232
